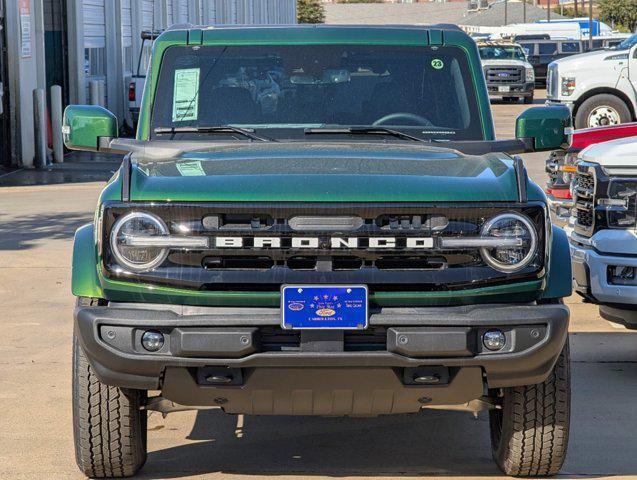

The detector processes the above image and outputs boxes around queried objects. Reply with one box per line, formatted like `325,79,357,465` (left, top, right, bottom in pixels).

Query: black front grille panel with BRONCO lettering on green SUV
101,203,546,293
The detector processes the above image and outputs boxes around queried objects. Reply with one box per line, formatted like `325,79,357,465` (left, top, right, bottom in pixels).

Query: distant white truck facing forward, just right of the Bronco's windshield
477,40,535,103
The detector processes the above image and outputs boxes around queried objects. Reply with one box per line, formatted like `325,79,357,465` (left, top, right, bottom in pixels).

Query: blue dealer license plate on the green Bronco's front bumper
281,285,367,330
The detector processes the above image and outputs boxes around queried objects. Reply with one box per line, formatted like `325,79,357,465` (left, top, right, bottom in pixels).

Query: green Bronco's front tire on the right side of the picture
489,340,571,477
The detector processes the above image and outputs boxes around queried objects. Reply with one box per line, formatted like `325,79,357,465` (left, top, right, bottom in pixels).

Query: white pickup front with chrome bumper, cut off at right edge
567,137,637,329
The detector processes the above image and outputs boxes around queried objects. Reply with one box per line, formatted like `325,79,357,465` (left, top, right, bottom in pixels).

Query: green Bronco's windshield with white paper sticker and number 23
151,45,483,140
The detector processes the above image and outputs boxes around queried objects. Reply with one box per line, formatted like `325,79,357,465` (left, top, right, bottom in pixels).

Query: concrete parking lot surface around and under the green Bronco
0,92,637,479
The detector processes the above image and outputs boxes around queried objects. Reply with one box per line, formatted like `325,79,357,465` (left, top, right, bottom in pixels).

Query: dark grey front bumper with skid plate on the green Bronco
75,304,569,415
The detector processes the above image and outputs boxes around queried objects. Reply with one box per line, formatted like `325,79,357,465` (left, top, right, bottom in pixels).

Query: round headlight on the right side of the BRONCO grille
480,213,538,273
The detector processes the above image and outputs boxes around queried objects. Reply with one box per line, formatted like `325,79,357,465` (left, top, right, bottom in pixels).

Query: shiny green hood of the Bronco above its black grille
130,142,518,202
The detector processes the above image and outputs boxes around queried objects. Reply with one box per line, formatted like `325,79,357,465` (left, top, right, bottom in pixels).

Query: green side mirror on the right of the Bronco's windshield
515,105,572,152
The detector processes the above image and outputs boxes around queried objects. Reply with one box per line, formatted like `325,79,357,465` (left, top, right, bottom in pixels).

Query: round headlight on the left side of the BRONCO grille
110,212,169,272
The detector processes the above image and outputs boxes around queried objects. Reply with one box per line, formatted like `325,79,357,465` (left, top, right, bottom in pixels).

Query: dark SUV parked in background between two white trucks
515,36,584,86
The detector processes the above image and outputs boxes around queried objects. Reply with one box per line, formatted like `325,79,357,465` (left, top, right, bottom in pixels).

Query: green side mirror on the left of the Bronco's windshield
62,105,118,152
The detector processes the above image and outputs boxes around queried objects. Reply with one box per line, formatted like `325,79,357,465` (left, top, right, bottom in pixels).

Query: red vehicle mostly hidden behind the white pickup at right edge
546,123,637,222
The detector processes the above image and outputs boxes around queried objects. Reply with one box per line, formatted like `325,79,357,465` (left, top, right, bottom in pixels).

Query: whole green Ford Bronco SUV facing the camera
63,25,571,477
